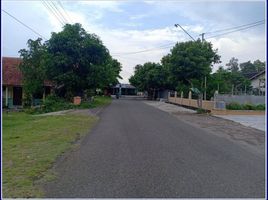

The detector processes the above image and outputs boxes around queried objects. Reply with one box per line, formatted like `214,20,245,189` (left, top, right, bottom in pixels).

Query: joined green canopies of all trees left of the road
20,23,121,101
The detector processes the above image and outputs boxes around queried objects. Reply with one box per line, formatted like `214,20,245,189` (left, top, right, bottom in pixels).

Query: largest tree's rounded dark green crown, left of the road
46,24,121,97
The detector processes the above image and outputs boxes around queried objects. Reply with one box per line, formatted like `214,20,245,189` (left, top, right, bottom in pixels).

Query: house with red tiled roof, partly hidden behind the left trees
2,57,51,108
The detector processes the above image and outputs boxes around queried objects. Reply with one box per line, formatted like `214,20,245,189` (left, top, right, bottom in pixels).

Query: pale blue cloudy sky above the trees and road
1,0,266,83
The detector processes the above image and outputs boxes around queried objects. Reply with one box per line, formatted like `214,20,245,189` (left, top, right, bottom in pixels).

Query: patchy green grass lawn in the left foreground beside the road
2,112,97,198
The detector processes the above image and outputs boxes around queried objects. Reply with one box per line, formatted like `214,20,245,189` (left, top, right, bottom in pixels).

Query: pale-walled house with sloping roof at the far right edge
249,70,265,95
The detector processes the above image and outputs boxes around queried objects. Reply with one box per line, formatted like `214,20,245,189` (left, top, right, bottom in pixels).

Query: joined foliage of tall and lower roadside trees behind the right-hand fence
129,40,220,99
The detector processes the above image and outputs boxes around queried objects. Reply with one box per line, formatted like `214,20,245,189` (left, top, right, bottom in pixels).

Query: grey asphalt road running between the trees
45,99,265,198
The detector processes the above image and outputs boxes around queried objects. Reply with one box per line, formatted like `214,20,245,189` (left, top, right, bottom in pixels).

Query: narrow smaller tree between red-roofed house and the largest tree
19,38,46,103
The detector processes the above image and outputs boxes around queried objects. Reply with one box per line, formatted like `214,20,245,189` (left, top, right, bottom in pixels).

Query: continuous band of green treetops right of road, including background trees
129,40,265,98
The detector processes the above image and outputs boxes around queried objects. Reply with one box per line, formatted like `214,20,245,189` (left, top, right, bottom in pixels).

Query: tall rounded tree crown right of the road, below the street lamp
161,40,220,89
